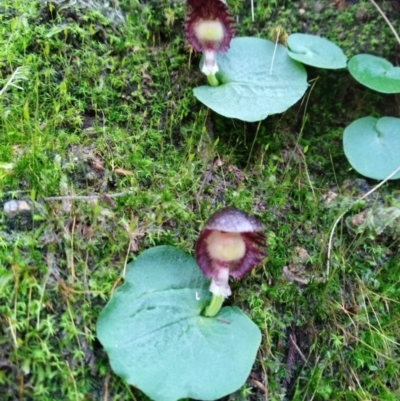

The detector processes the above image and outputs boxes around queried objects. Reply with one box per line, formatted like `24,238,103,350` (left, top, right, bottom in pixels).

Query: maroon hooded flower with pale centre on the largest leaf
195,207,266,298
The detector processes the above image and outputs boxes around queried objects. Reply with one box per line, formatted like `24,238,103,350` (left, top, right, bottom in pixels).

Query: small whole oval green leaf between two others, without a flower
287,33,347,69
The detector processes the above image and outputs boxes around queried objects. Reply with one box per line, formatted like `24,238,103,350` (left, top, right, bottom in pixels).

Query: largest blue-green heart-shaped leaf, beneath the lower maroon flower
97,246,261,401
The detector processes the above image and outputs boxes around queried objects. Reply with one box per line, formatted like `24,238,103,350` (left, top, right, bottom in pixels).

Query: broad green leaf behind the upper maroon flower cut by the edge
194,38,308,122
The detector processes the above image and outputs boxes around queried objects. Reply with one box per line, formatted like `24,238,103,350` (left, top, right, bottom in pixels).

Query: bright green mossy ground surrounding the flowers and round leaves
0,0,400,401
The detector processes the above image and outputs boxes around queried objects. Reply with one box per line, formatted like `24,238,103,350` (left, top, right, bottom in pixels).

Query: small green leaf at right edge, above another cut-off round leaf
348,54,400,93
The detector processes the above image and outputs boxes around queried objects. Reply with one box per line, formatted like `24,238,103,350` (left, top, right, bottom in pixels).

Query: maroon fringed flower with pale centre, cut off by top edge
184,0,235,75
